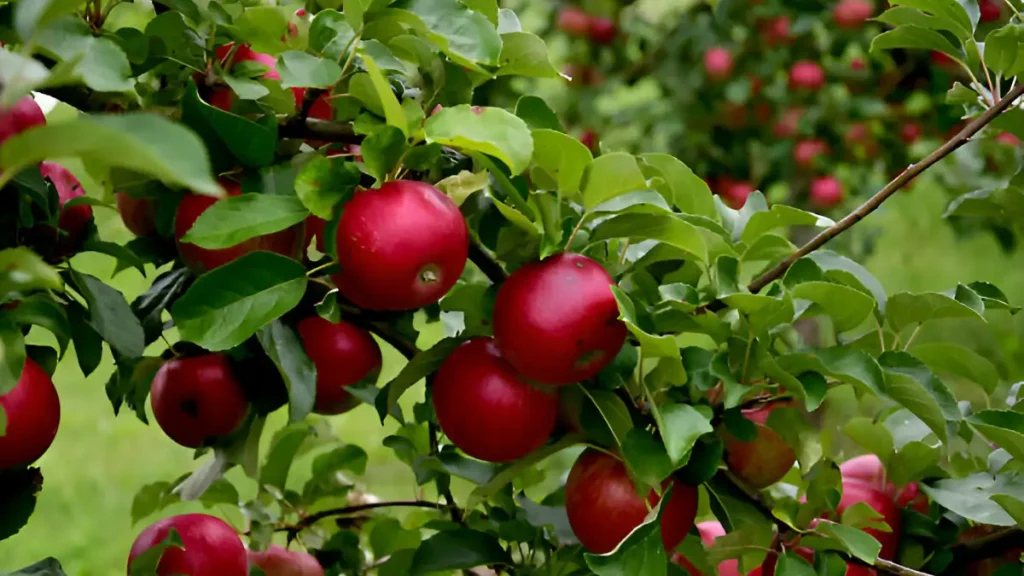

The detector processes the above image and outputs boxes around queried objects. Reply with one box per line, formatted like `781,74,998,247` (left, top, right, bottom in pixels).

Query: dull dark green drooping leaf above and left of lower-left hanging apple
71,271,145,358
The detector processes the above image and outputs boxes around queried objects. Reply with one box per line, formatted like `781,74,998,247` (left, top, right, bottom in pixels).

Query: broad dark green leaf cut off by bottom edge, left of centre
412,528,512,575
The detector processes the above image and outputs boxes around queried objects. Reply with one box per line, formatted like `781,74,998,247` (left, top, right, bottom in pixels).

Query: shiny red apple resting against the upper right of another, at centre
494,252,627,384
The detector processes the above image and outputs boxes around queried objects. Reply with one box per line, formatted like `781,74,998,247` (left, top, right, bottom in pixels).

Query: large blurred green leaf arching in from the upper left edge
0,113,223,196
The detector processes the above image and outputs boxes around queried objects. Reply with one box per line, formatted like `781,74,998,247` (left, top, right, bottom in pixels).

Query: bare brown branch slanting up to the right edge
745,83,1024,291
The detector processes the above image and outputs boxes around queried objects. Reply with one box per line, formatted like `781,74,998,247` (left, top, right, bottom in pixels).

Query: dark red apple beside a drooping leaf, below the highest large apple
297,316,382,414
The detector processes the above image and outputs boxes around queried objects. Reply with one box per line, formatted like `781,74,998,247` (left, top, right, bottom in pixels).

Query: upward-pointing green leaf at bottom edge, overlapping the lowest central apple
584,496,671,576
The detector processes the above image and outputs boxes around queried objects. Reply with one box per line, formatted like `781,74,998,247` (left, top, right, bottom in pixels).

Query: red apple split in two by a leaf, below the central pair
565,448,697,554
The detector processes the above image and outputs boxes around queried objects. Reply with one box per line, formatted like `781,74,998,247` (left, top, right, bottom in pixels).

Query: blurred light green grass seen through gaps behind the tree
0,171,1024,576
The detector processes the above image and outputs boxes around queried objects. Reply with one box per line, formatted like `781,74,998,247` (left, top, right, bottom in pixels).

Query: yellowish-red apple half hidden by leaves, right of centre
722,402,797,490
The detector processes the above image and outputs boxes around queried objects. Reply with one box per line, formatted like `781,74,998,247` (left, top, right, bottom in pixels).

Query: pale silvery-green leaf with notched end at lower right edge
919,471,1024,526
